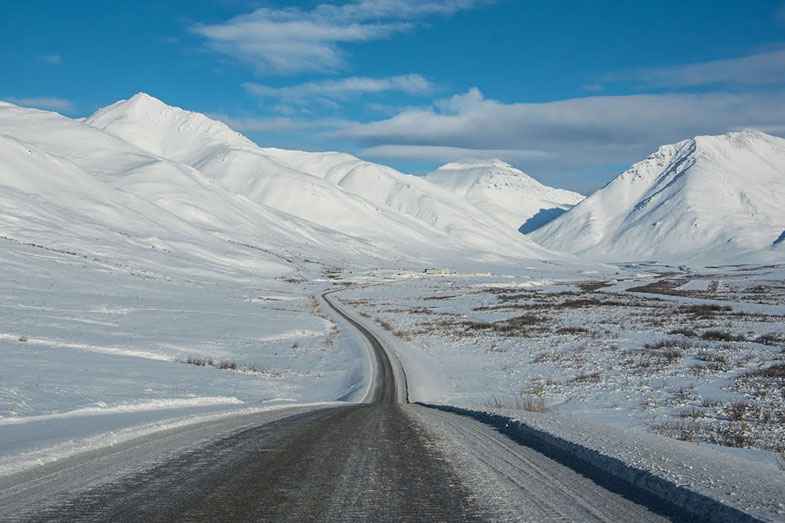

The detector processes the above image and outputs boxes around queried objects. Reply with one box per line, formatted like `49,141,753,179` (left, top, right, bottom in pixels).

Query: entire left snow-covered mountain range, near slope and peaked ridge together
0,94,558,278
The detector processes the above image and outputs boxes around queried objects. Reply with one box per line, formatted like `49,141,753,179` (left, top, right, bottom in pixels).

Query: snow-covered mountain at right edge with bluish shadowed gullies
530,131,785,262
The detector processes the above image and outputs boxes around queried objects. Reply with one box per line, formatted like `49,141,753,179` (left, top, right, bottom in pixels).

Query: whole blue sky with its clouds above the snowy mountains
0,0,785,194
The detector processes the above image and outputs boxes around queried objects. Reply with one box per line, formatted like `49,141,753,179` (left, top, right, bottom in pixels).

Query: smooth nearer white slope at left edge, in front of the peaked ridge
0,104,387,277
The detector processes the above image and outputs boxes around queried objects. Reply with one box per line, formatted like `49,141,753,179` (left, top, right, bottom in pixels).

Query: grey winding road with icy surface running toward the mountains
0,295,696,522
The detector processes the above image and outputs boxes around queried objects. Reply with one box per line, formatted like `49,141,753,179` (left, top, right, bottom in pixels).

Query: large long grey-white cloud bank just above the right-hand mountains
332,89,785,172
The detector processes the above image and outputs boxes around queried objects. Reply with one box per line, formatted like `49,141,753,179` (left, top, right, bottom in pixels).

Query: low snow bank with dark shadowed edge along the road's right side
421,403,785,522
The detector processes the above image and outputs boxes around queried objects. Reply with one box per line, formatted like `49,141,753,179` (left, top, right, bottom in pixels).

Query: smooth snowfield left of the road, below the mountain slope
0,241,369,474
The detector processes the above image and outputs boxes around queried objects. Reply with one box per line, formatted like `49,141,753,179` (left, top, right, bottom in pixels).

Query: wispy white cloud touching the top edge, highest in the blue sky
192,0,489,74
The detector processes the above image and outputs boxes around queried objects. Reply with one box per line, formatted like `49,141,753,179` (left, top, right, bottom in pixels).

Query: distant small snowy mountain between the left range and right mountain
425,160,584,233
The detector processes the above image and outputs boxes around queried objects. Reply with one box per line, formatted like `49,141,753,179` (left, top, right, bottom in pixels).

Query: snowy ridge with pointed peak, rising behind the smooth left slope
86,93,548,259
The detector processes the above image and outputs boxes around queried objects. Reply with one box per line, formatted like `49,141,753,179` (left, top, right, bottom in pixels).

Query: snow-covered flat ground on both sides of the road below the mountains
0,236,785,519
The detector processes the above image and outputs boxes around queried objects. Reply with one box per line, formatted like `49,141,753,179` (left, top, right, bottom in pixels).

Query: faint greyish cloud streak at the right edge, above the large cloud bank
603,49,785,88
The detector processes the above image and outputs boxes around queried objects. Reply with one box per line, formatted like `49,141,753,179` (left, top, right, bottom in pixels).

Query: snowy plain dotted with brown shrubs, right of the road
342,264,785,469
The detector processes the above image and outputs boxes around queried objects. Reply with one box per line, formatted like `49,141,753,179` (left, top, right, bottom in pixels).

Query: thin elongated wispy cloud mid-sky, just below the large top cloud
243,74,433,104
